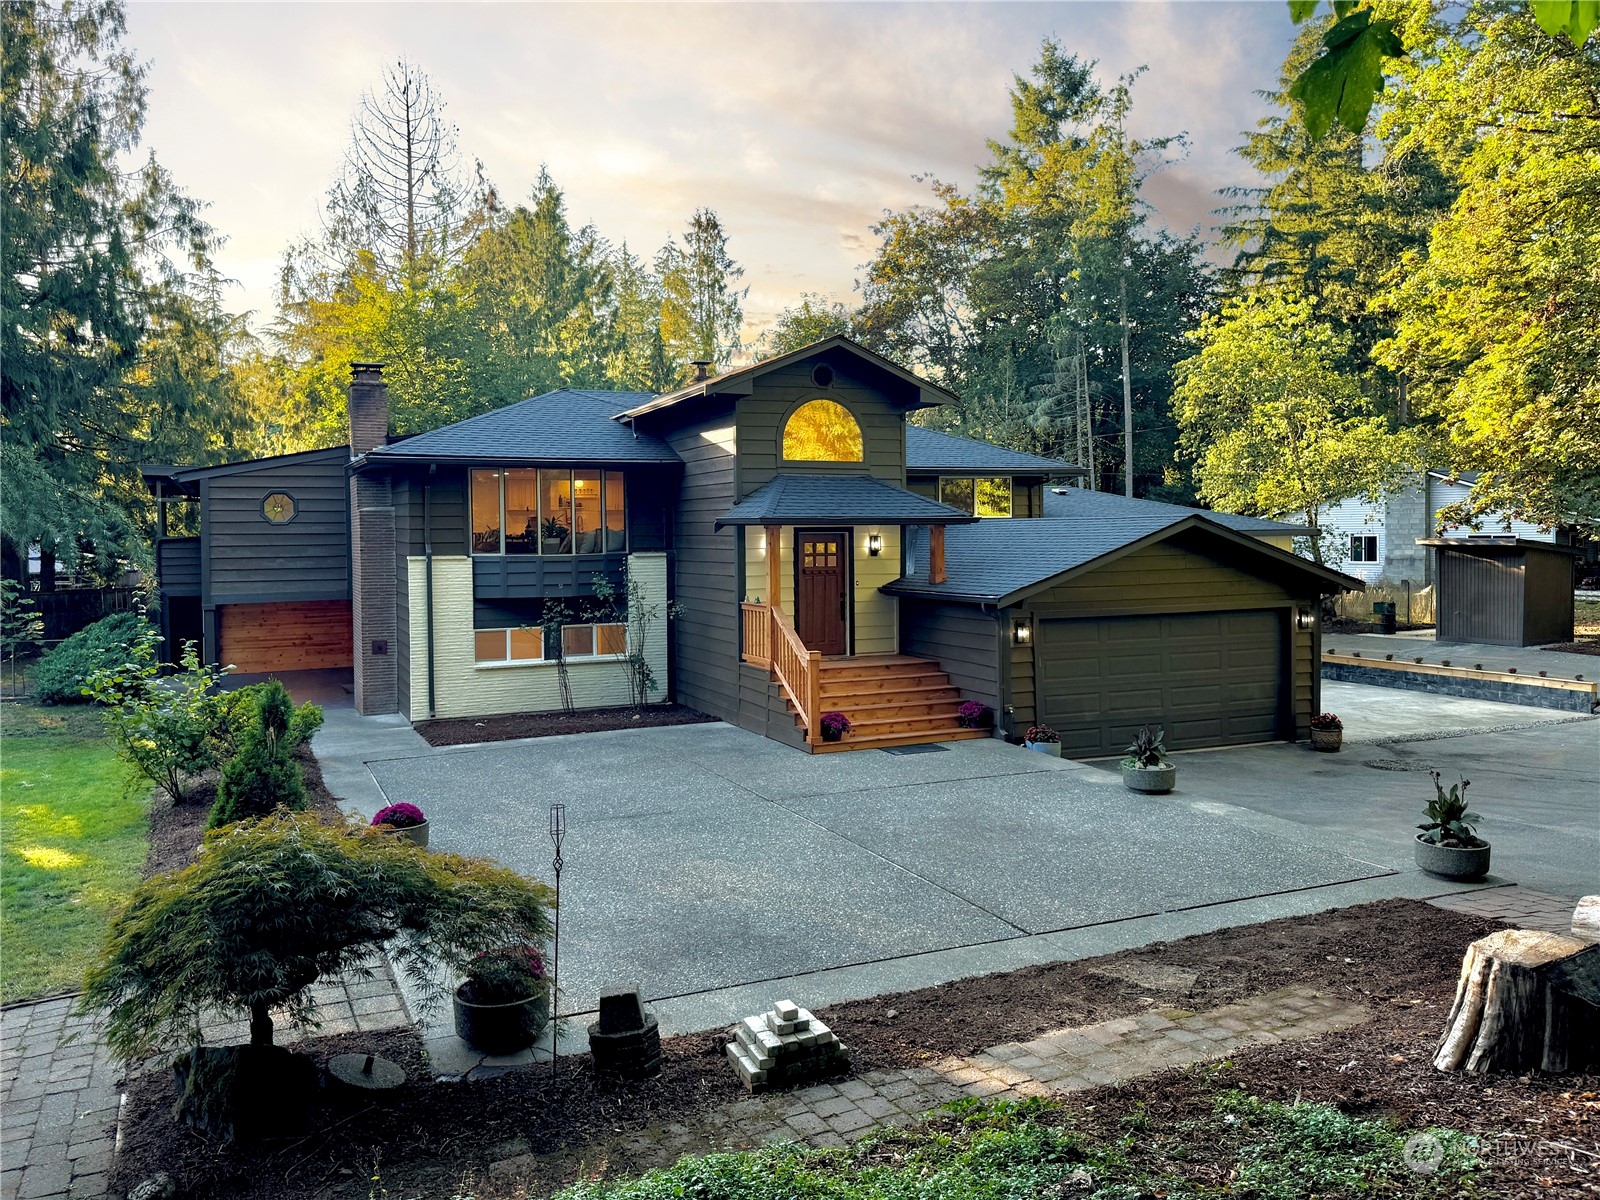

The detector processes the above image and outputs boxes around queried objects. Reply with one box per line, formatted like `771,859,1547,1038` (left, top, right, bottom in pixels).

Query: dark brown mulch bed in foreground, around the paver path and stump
112,901,1600,1200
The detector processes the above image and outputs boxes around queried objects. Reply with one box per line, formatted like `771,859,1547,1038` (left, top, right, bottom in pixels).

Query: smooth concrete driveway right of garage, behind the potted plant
1101,682,1600,898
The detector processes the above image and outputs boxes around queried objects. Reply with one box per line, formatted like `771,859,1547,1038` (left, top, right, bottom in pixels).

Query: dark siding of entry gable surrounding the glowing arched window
739,358,906,499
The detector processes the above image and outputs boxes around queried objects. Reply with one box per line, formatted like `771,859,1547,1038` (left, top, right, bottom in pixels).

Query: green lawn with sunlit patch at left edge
0,704,147,1003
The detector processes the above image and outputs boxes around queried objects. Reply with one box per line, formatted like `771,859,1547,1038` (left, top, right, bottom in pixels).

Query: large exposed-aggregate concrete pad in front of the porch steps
368,725,1450,1027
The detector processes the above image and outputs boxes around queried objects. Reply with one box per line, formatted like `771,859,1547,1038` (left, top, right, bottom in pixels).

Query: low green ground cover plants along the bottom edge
560,1090,1478,1200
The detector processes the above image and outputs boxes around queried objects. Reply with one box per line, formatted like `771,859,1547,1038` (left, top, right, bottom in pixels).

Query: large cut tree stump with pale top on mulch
1434,930,1600,1074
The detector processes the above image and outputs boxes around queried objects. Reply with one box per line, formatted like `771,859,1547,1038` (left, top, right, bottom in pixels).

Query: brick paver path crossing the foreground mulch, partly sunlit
490,986,1368,1181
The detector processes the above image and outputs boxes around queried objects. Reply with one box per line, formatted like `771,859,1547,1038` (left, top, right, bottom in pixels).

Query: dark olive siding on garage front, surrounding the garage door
1008,534,1320,739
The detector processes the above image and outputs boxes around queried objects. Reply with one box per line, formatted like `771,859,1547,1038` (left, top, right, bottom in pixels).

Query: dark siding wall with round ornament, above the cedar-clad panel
202,454,350,606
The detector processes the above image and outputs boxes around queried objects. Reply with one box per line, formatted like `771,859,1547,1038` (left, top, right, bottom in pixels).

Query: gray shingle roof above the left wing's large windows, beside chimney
366,387,680,462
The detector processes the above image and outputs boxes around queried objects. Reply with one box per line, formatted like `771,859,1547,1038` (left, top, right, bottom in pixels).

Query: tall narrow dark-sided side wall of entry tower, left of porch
667,402,739,722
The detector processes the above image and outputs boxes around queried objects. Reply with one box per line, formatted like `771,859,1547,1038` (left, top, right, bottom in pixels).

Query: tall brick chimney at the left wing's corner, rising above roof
350,363,400,717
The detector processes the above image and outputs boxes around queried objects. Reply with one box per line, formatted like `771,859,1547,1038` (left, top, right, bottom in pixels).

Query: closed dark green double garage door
1037,610,1283,758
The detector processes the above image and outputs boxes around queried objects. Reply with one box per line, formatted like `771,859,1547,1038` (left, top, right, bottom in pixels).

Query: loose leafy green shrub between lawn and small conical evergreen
85,624,222,805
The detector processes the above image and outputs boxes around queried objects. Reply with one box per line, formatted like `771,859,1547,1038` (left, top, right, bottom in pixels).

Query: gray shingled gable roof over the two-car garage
883,504,1365,606
